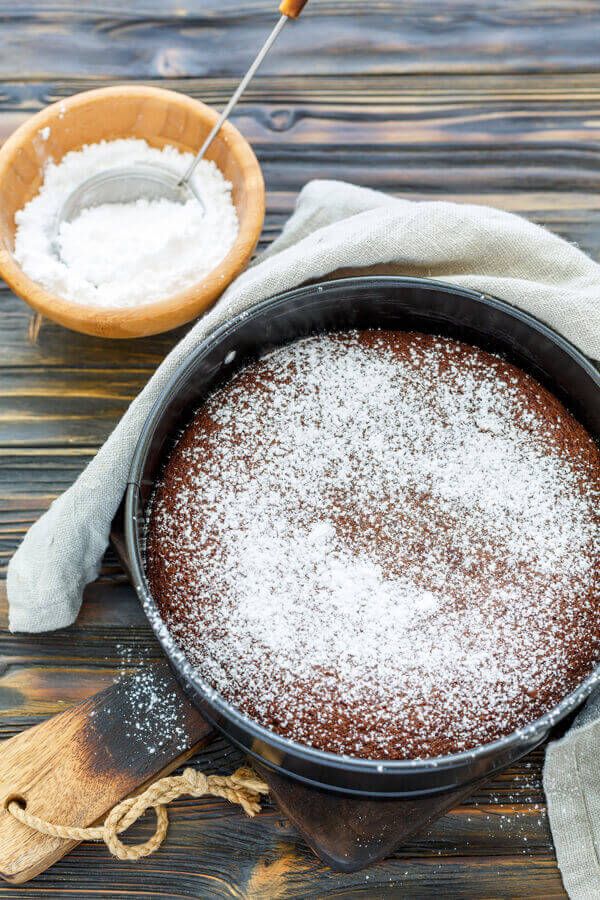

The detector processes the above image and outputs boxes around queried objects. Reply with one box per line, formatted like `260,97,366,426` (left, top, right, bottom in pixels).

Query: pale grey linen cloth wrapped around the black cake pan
8,181,600,900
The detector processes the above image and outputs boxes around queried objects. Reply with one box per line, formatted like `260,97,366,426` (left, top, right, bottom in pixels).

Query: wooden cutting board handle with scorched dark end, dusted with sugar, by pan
0,663,213,884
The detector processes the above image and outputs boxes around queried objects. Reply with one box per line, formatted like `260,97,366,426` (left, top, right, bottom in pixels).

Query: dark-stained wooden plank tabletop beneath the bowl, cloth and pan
0,0,600,898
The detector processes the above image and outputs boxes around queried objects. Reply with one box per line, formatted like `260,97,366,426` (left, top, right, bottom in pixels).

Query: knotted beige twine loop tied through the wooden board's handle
6,768,269,860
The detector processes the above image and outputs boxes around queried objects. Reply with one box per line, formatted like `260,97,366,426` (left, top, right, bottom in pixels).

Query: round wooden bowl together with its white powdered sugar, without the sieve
0,86,264,338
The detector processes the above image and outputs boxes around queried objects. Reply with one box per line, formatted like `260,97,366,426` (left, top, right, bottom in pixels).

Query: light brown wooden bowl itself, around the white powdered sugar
0,86,265,338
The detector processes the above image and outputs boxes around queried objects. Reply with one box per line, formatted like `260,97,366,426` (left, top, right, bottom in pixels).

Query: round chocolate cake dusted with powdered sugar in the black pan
146,331,600,760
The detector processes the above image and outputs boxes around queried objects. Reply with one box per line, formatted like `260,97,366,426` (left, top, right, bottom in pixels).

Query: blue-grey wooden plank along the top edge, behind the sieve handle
0,0,600,80
